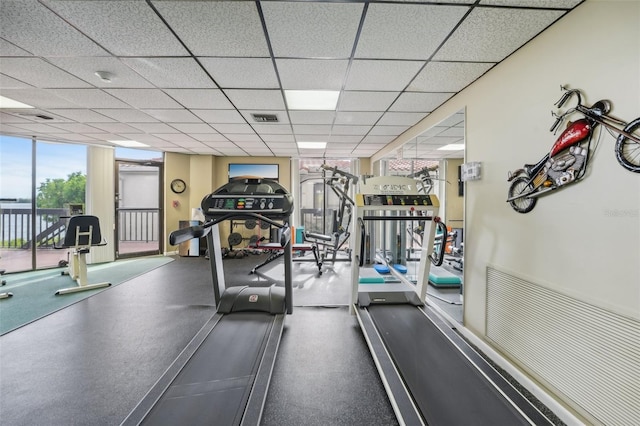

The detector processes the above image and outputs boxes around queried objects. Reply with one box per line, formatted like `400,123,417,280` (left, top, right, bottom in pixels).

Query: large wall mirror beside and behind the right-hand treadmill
379,110,465,323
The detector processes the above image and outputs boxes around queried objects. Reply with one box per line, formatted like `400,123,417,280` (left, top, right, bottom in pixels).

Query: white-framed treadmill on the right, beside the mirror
350,176,553,426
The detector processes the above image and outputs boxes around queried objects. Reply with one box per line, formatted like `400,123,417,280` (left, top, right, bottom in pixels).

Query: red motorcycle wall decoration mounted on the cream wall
507,87,640,213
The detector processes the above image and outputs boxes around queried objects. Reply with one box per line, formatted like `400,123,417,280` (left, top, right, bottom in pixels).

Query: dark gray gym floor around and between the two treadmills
0,256,395,425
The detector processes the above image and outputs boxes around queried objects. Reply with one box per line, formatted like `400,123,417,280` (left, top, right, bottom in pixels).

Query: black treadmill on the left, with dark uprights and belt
122,178,293,425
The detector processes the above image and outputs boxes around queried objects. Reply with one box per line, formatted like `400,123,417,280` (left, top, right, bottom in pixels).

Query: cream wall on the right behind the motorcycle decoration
373,0,640,424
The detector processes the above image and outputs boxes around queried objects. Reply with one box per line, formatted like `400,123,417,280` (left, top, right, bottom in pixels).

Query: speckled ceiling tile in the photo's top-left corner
0,0,107,56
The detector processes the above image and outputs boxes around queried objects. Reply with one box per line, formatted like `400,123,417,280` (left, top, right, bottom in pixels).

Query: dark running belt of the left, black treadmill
142,313,275,425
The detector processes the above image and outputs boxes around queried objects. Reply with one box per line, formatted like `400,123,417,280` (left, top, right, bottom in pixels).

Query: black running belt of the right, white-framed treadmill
368,305,530,426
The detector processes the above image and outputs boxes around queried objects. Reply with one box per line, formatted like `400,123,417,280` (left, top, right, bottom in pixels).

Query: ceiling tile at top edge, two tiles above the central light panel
261,2,364,58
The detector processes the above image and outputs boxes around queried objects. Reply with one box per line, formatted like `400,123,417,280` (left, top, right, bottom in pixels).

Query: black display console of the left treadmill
201,179,293,219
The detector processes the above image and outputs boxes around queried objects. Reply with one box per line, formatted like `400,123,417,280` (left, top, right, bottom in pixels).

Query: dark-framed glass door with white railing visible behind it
115,160,163,259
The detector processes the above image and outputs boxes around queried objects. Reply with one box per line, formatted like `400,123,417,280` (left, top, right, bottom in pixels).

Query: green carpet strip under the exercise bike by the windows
0,256,173,335
